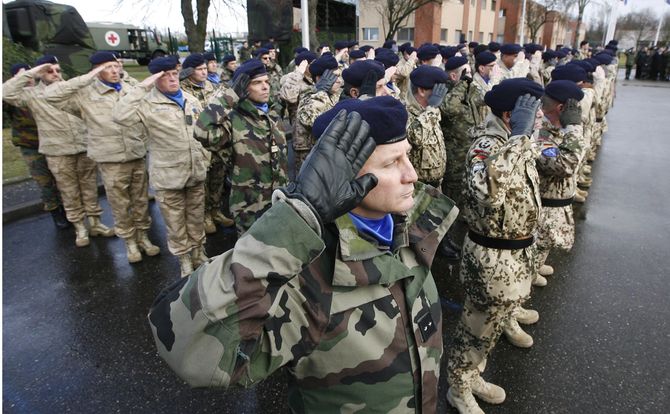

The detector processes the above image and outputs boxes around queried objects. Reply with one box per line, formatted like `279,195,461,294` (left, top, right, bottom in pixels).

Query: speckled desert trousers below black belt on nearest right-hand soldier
447,236,536,391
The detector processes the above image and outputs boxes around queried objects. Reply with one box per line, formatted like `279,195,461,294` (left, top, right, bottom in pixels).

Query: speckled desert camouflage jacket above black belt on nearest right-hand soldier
464,114,541,239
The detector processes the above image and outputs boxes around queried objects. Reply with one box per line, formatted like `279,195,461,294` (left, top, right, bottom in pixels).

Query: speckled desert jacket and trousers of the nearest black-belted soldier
448,115,541,392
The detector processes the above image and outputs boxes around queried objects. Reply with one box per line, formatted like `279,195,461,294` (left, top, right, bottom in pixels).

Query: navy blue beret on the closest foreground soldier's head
312,96,407,145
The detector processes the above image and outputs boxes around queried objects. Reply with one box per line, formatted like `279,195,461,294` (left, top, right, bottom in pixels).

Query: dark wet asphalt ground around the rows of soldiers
2,78,670,414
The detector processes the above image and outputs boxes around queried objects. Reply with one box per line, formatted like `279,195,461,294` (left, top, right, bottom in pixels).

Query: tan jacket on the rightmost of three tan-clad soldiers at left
113,86,209,190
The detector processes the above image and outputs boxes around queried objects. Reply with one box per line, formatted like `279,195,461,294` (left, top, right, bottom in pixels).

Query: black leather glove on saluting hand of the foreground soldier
282,110,377,227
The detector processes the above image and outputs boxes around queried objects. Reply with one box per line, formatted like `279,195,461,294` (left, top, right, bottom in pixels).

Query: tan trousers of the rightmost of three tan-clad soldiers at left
156,183,205,256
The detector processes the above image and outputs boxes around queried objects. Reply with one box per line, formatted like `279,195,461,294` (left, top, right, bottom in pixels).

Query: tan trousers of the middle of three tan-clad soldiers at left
99,158,151,239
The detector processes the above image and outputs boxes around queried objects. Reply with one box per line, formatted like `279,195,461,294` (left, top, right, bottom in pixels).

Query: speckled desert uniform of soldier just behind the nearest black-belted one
537,118,586,269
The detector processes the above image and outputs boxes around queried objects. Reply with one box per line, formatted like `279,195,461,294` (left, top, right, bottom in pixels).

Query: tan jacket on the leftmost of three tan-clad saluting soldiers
2,72,86,156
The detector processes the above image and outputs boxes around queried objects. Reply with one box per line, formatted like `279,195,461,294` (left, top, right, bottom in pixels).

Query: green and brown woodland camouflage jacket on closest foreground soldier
148,183,458,413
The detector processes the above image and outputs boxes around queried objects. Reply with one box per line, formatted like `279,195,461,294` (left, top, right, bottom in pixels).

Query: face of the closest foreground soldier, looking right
354,139,418,218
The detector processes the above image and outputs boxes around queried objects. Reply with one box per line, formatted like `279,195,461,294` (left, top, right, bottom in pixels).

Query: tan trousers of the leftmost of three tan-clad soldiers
46,152,102,223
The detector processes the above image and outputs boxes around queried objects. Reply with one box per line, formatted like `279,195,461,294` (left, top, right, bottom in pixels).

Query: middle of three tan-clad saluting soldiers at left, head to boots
44,52,160,263
